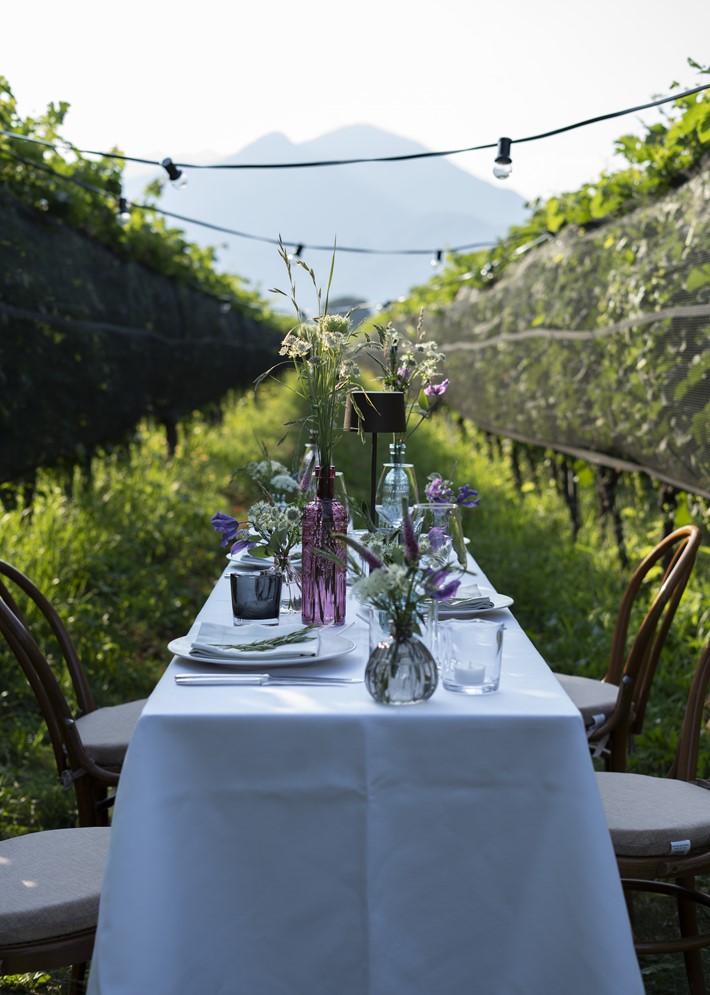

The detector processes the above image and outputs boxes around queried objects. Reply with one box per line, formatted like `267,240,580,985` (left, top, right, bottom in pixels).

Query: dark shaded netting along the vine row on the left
0,194,281,483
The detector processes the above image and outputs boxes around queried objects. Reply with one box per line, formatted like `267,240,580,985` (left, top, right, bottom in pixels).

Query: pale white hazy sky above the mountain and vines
0,0,710,198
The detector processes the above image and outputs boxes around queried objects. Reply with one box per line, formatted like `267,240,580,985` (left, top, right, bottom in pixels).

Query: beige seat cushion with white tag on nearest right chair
597,771,710,857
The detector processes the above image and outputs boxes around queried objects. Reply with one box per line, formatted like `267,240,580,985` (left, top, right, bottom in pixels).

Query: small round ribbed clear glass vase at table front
365,634,439,705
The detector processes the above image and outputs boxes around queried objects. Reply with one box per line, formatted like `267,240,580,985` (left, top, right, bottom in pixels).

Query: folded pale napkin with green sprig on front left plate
190,622,320,660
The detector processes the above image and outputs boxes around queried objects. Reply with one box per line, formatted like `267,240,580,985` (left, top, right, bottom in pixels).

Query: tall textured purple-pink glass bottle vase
301,466,348,625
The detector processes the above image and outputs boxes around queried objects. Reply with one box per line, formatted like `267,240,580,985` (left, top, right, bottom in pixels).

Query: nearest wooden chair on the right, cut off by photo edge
597,641,710,995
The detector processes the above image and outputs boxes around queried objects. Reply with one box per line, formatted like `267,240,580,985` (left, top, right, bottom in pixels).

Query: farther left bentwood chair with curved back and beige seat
0,560,145,826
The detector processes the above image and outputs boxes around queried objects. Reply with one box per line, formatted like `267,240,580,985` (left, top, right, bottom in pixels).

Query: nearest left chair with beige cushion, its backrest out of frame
0,827,111,995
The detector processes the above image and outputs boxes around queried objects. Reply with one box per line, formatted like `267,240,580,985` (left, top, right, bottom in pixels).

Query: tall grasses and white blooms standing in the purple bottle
257,240,360,467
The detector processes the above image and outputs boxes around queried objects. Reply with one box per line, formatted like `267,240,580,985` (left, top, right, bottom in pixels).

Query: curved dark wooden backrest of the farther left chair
0,560,118,826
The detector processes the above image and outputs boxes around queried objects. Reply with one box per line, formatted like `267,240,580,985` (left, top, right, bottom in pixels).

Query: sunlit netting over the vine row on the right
427,170,710,506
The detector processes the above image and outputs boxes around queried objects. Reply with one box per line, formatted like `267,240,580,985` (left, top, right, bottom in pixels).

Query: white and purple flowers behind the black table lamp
358,312,451,442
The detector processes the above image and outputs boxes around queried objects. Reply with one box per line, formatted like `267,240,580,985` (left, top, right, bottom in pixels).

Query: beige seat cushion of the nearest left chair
0,826,111,947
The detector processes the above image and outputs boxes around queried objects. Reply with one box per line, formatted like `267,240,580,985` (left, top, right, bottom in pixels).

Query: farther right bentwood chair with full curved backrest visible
555,525,700,771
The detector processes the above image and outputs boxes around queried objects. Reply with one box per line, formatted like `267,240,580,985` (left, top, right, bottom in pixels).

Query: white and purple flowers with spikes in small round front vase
343,502,460,639
